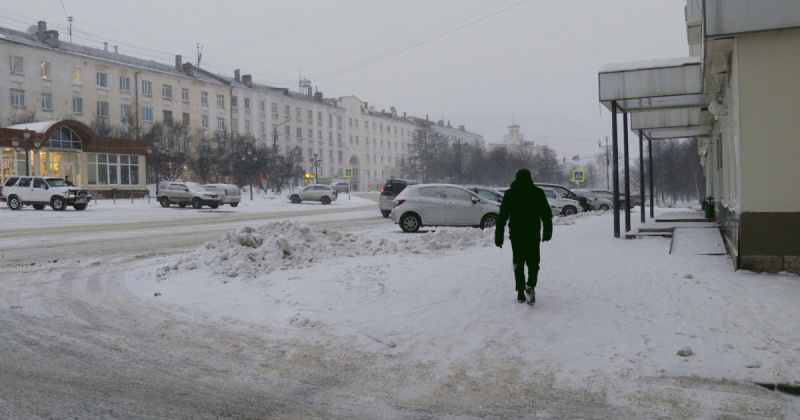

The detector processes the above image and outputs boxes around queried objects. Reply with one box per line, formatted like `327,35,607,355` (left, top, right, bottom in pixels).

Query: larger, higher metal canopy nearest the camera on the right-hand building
598,57,716,113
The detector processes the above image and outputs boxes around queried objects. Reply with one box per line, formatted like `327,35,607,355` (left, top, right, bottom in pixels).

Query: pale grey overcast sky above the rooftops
0,0,688,163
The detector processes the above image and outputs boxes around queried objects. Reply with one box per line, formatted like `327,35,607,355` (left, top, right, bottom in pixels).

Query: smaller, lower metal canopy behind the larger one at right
631,108,714,140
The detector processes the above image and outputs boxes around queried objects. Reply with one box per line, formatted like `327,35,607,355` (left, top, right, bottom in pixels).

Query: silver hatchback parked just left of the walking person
391,184,500,232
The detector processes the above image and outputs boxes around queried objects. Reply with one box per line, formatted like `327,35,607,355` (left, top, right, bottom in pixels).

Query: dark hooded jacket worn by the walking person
495,171,553,240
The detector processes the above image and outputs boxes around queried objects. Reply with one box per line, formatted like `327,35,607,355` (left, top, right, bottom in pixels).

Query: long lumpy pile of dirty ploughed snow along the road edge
157,221,494,278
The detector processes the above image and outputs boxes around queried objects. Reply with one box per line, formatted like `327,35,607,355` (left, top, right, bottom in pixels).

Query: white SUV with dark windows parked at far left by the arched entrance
3,176,92,210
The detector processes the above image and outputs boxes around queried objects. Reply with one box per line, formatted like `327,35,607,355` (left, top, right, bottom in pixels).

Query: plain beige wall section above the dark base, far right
735,30,800,212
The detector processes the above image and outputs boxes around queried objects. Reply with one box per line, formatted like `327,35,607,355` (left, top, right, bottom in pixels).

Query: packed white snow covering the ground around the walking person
3,190,800,418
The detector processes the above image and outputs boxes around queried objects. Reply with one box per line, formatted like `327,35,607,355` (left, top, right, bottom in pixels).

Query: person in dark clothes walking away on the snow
494,168,553,305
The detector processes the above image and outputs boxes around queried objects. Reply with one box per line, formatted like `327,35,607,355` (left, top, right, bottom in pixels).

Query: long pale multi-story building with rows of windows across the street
0,22,482,194
